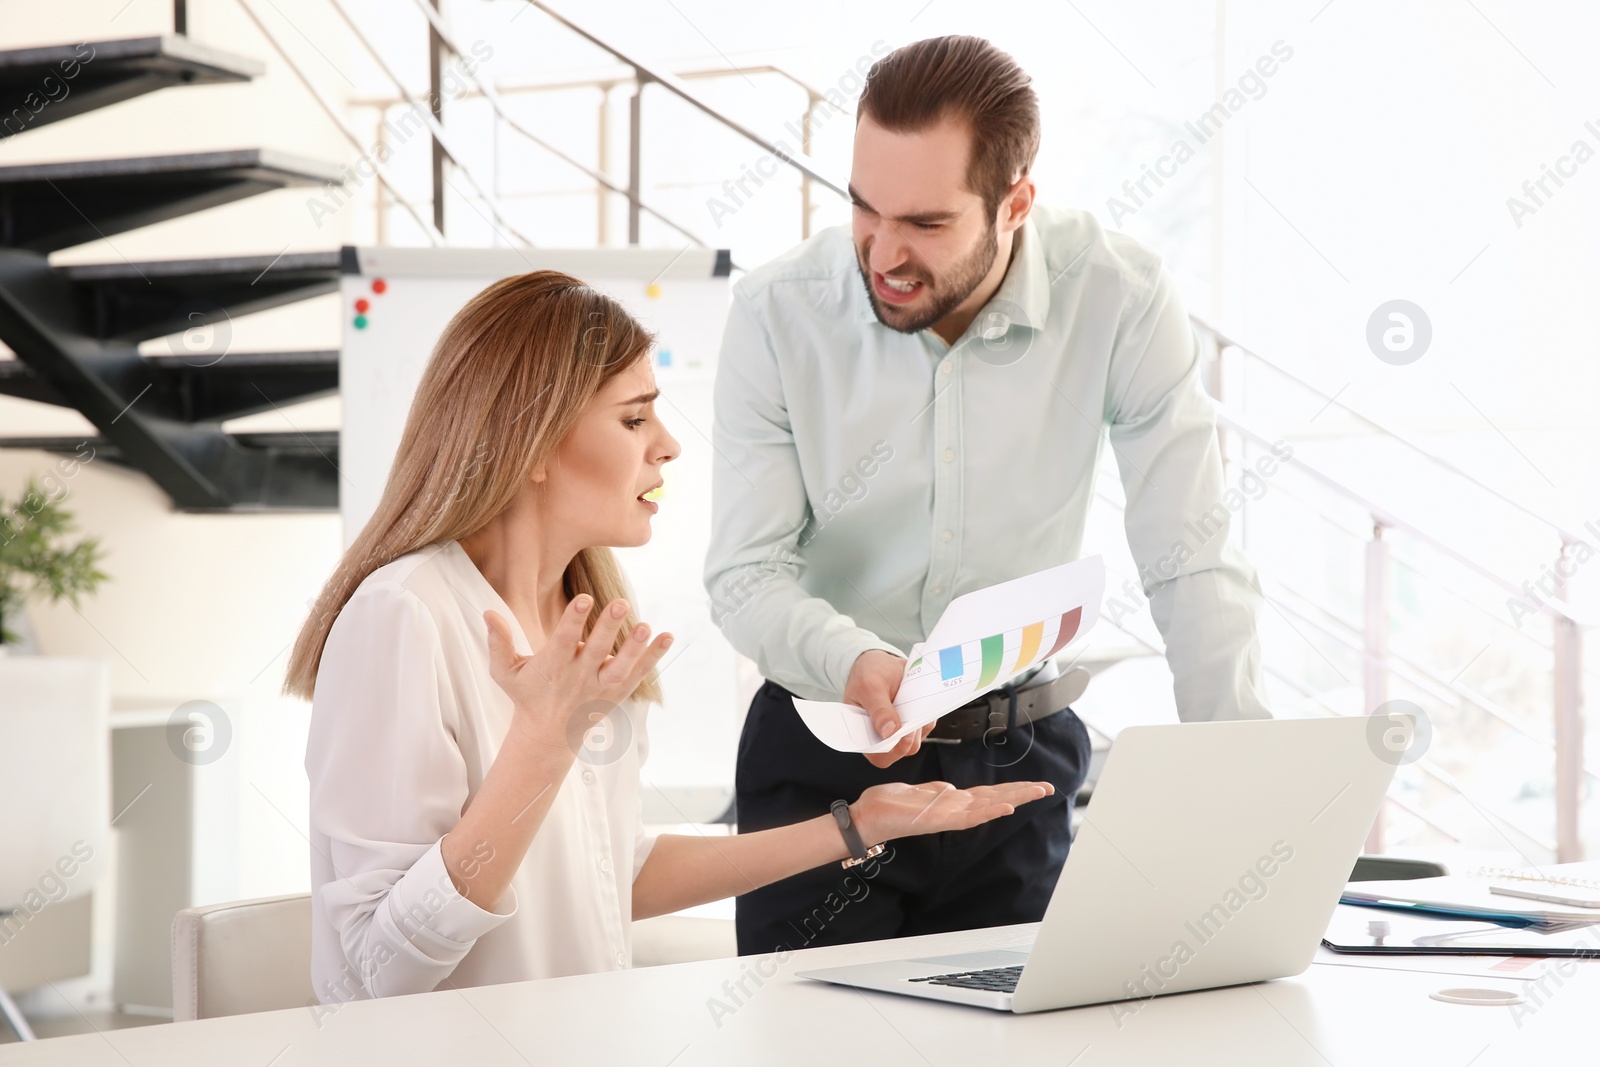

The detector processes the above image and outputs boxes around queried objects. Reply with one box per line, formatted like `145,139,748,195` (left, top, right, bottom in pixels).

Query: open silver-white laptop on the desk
798,717,1395,1013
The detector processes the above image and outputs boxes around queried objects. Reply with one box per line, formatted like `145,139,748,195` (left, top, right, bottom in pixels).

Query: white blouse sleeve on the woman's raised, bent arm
306,584,517,1001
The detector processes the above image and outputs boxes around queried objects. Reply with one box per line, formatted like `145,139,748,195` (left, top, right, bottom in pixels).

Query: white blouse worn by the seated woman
306,541,654,1003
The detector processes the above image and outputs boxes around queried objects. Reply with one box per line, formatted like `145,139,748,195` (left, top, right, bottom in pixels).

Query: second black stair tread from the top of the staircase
0,149,341,253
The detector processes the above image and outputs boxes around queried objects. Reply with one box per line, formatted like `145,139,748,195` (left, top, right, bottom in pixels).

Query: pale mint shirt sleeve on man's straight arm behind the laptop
1107,267,1270,721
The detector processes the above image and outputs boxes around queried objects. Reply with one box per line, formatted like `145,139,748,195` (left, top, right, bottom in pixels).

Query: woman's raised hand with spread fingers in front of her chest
483,593,672,755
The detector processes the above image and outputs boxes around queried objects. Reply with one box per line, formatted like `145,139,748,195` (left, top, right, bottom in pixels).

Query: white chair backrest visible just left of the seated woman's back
173,893,317,1022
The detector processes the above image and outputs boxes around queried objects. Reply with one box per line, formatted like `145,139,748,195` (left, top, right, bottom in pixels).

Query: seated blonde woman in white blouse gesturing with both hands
285,270,1051,1001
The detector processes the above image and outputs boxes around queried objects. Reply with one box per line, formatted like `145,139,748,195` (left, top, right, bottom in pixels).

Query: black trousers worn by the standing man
734,681,1090,955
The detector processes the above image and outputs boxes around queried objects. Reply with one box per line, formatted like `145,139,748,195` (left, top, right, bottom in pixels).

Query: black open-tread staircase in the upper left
0,37,339,512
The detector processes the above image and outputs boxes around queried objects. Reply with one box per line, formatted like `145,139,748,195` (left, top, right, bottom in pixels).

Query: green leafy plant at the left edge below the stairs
0,478,107,651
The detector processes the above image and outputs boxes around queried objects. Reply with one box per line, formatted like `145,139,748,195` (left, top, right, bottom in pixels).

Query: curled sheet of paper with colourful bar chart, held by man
795,555,1106,752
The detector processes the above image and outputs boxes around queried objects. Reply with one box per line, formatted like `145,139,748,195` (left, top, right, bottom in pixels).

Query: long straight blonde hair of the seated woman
283,270,661,701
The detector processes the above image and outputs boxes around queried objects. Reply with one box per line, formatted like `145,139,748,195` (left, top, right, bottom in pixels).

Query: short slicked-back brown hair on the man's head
856,37,1038,219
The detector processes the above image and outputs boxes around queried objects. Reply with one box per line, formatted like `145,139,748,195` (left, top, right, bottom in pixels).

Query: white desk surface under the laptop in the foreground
0,926,1600,1067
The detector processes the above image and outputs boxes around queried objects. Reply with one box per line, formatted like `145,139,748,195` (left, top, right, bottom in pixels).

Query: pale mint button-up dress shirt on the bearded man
706,206,1267,721
